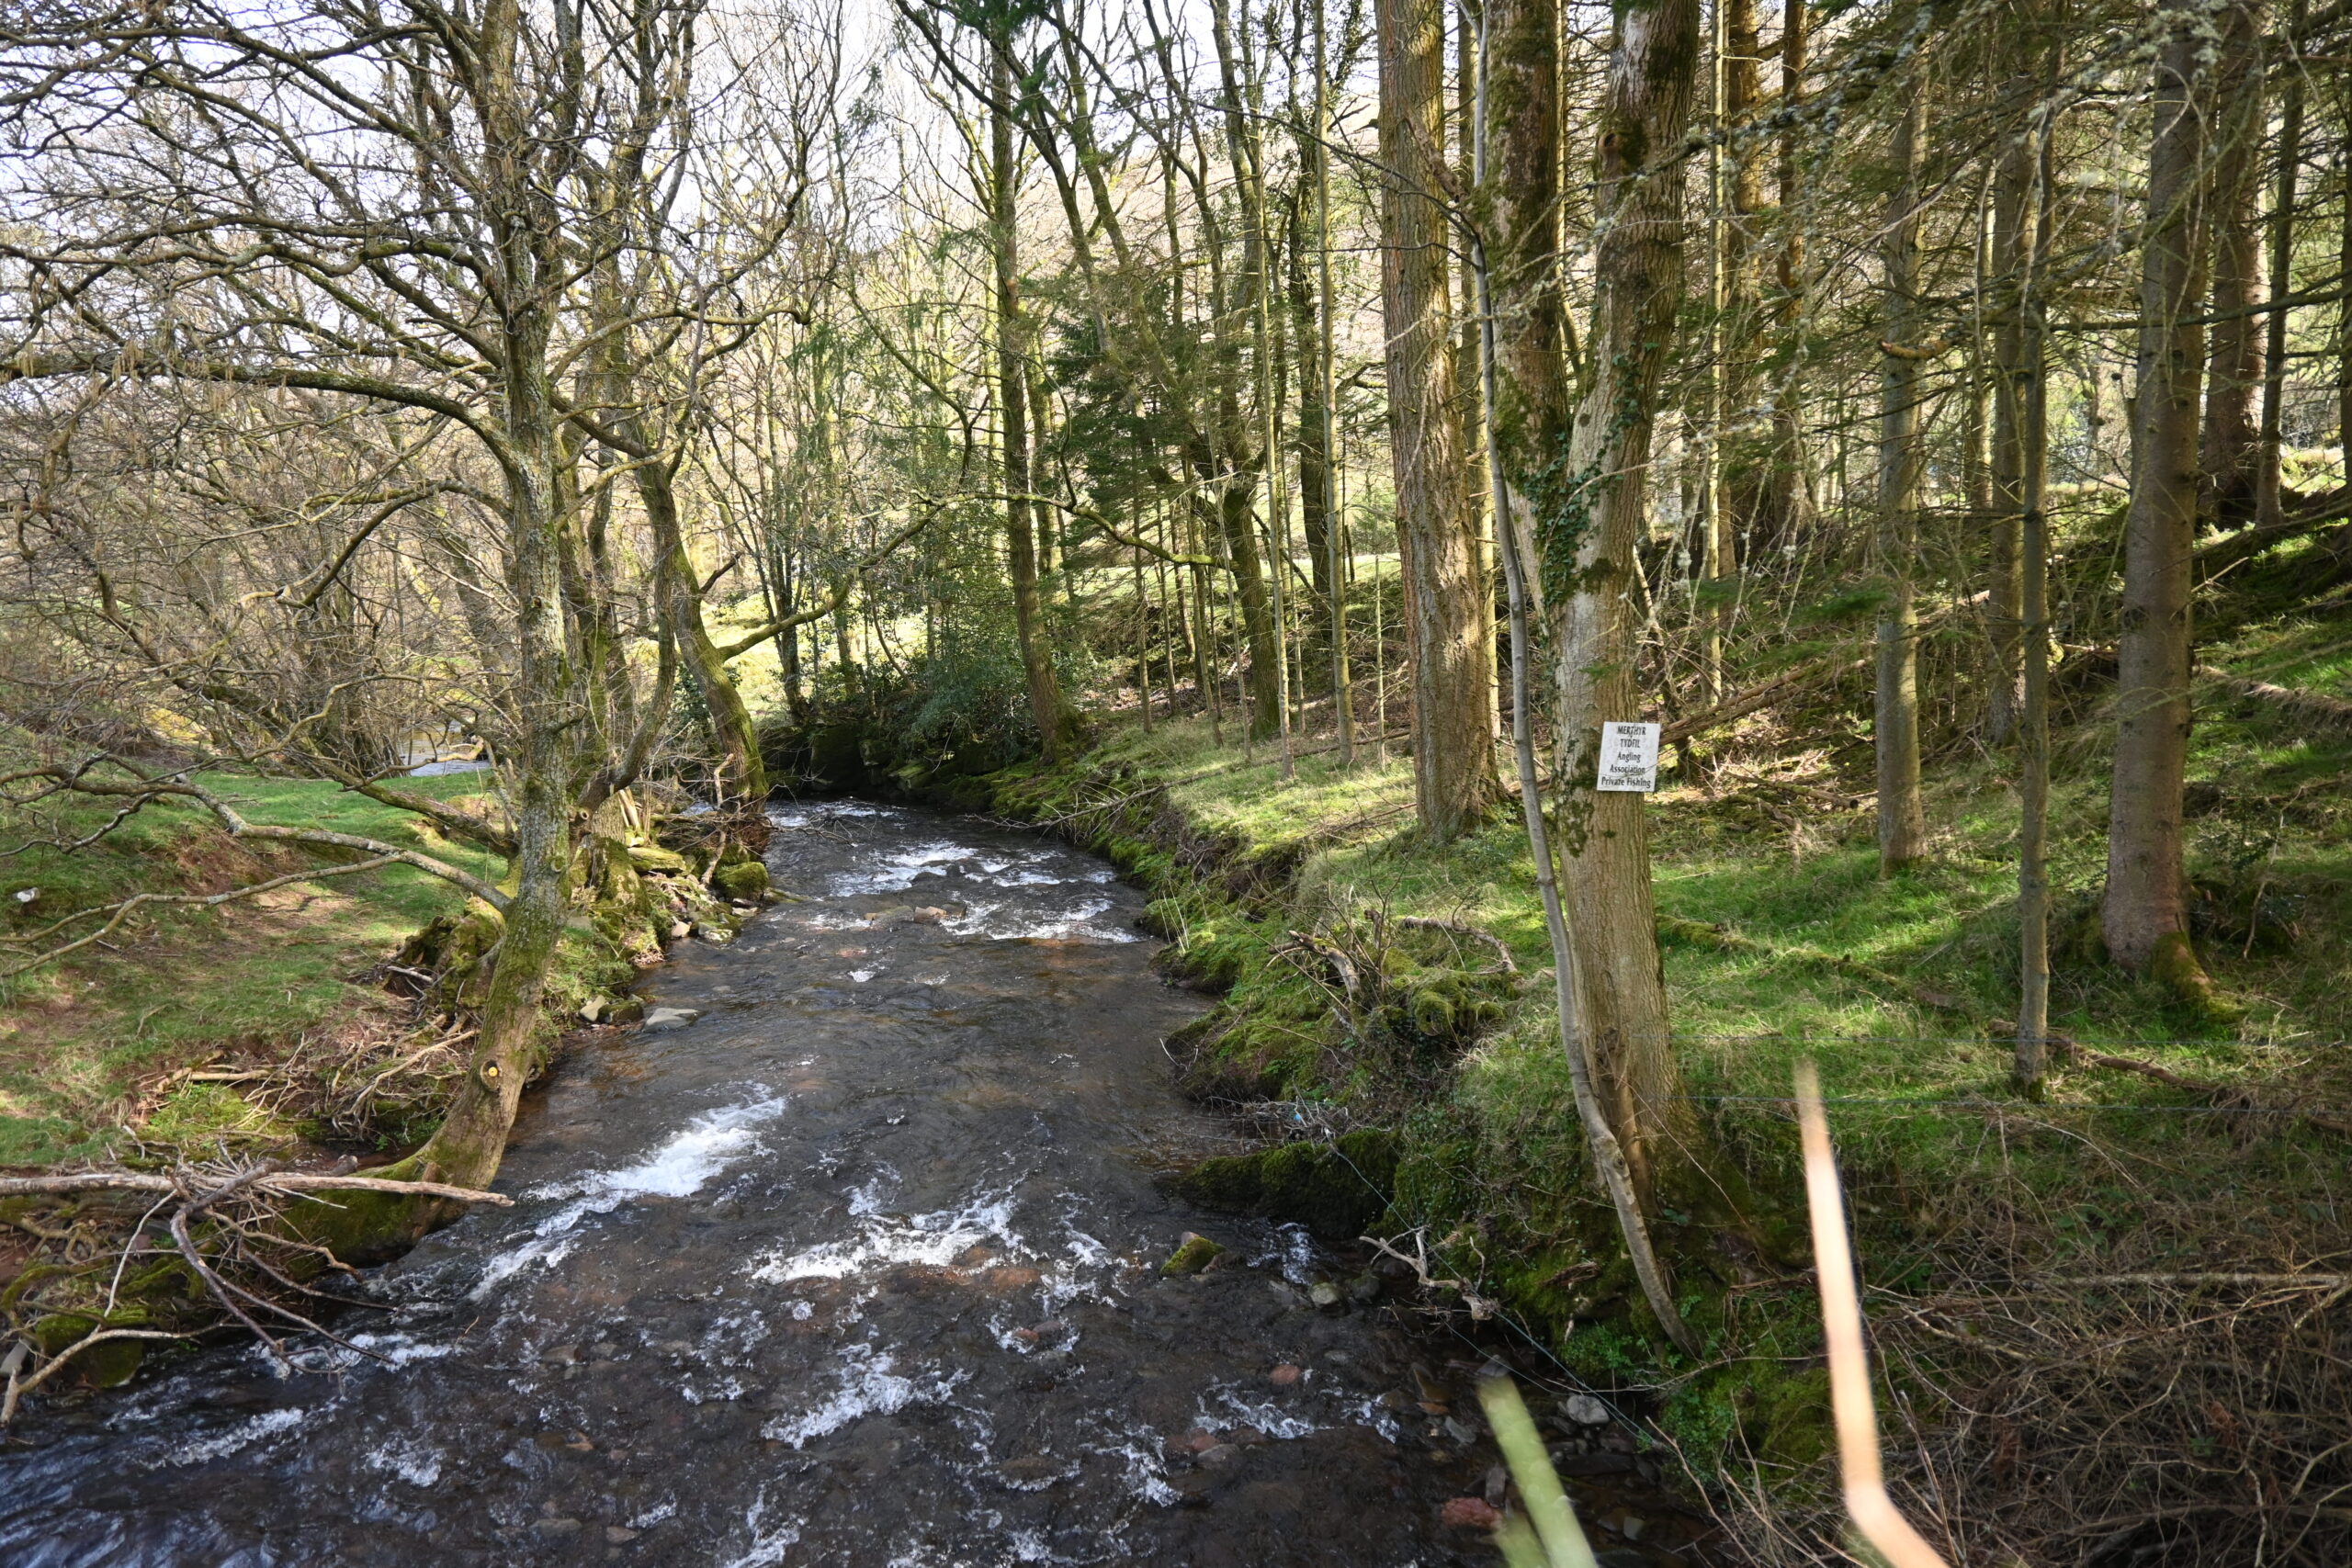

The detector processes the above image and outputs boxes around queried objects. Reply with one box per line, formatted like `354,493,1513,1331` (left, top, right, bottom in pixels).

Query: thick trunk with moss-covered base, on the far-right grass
2100,7,2209,997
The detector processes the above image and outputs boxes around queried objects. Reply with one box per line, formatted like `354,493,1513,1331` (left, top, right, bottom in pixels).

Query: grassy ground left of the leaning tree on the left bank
0,773,499,1166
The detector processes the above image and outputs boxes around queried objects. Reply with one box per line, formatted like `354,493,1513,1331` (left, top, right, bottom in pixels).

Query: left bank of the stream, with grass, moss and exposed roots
0,751,767,1411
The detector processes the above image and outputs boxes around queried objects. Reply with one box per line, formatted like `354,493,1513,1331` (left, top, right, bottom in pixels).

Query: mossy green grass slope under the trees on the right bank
1021,602,2352,1485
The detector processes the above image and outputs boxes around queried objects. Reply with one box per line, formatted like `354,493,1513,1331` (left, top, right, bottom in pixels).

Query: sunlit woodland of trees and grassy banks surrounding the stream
0,0,2352,1565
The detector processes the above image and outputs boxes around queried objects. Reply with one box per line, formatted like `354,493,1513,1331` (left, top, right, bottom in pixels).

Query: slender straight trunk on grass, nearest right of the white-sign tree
1874,96,1927,877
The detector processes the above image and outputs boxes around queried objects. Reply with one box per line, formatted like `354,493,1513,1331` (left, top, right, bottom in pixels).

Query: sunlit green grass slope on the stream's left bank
0,776,499,1164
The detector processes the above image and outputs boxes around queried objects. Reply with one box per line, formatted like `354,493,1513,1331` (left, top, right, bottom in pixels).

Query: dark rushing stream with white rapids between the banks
0,802,1674,1568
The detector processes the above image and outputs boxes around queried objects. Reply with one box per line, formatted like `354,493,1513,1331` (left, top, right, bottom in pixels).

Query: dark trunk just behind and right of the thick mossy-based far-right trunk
2199,0,2263,529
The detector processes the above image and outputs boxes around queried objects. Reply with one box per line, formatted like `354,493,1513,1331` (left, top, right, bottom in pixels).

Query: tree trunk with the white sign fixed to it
1532,0,1698,1203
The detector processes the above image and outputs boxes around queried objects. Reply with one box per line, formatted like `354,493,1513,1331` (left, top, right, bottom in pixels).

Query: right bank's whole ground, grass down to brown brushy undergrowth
995,597,2352,1561
